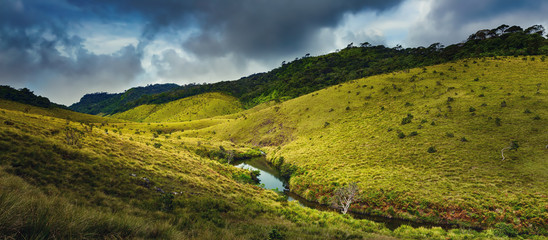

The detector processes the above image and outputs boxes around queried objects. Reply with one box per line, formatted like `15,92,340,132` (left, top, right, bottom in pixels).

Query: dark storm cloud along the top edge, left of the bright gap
67,0,401,57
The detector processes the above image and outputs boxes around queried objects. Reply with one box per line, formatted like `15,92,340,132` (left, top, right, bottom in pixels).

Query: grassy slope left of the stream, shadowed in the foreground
0,104,424,239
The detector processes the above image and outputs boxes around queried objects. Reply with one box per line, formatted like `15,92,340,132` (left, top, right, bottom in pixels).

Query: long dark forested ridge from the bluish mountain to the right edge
71,25,548,114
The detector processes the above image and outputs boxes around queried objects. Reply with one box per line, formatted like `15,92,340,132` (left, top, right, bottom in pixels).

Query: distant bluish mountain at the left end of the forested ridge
69,83,179,114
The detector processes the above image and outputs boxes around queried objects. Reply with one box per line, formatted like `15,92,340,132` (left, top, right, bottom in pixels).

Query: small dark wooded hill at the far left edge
0,85,67,108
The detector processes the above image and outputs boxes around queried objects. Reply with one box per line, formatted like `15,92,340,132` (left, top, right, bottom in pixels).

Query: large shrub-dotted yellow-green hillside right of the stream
193,56,548,234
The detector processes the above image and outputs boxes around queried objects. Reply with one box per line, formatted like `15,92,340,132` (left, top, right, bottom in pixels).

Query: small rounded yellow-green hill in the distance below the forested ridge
112,93,242,122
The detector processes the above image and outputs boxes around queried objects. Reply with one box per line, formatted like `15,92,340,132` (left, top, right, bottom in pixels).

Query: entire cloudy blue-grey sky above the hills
0,0,548,105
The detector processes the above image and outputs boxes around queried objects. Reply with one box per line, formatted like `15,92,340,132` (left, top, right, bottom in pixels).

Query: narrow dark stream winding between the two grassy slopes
233,157,478,230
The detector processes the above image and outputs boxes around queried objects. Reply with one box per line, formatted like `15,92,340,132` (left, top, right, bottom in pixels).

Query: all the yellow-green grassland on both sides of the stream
0,56,548,239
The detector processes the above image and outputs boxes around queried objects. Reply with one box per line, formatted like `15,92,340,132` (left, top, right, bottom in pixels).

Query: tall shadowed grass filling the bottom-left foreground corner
0,171,183,239
